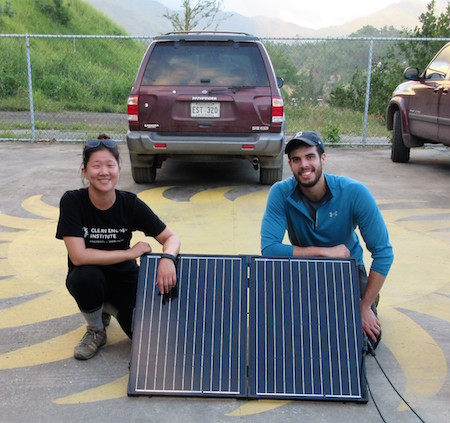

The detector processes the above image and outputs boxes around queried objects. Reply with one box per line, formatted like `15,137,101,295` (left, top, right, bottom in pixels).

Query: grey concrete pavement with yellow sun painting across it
0,142,450,423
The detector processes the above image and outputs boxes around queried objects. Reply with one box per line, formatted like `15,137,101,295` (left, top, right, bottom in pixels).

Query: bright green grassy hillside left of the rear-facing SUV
0,0,145,112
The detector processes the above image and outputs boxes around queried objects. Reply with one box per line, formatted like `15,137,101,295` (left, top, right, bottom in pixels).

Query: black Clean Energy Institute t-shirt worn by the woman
56,188,166,272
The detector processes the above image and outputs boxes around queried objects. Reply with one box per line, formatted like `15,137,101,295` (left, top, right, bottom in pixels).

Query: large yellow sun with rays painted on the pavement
0,187,450,416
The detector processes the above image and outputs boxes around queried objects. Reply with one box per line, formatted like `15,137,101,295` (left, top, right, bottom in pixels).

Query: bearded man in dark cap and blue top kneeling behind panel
261,131,394,347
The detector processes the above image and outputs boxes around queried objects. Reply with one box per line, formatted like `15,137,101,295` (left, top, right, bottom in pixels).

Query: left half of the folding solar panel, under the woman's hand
128,255,248,397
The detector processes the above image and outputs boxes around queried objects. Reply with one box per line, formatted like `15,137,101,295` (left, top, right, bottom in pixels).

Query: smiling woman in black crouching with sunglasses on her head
56,135,180,360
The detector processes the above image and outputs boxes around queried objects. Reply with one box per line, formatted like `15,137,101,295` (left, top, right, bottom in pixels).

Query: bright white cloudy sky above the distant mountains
164,0,430,29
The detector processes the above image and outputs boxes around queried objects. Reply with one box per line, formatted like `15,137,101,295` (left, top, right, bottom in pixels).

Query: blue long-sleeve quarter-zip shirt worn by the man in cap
261,174,394,276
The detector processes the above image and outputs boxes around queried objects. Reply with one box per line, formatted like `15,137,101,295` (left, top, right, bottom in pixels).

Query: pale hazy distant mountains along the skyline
84,0,447,37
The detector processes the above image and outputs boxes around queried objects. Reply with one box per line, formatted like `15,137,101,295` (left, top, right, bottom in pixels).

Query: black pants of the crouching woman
66,266,139,338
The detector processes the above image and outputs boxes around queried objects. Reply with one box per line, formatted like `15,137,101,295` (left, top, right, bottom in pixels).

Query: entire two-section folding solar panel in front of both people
128,254,367,402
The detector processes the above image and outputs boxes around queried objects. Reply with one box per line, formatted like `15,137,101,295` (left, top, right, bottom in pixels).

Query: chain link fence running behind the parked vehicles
0,34,450,146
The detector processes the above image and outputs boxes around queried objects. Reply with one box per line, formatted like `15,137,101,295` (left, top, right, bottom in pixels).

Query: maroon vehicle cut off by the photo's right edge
386,43,450,163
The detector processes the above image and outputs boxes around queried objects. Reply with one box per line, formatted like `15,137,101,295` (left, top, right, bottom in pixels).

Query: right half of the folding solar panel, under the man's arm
249,258,367,402
